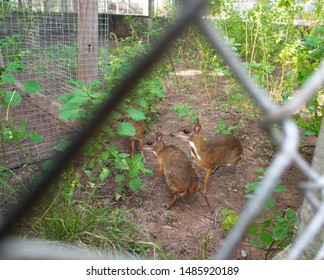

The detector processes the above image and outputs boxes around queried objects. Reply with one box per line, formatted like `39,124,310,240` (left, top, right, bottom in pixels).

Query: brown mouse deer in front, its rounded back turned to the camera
141,132,213,212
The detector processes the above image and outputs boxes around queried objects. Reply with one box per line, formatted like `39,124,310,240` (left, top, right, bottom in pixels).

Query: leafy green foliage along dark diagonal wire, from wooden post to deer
59,29,165,200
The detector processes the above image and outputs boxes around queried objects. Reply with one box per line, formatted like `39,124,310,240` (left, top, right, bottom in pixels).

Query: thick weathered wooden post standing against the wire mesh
78,0,98,84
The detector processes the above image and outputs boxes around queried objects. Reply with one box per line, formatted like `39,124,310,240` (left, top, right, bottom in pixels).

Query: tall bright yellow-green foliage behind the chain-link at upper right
194,0,324,136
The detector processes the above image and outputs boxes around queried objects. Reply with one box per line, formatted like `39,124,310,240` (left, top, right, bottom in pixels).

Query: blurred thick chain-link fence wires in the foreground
0,1,324,259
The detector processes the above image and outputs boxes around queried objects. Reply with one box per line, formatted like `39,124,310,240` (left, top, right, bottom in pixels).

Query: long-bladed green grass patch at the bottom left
23,167,160,257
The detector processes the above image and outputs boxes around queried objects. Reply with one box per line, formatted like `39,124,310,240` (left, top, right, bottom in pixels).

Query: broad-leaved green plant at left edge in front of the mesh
0,62,44,201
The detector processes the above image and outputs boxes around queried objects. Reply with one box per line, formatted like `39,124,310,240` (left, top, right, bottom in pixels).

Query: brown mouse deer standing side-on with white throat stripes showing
171,119,245,193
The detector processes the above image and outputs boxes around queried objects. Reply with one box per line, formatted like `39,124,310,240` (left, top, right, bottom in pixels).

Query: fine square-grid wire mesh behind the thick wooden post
0,0,109,168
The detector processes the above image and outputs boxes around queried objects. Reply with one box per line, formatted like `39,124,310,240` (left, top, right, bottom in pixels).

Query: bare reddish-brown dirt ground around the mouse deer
110,66,314,259
